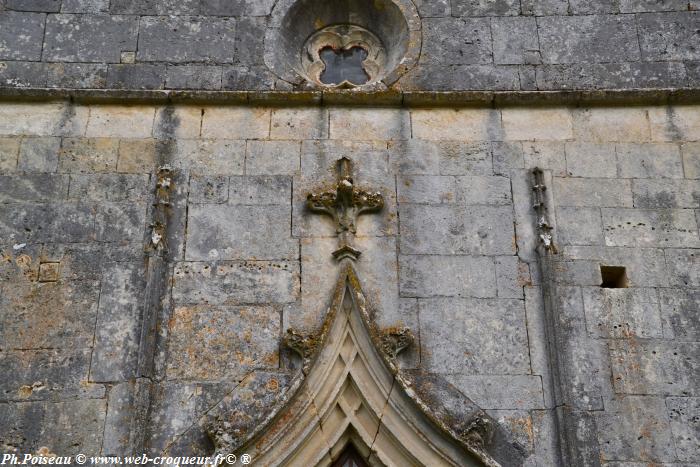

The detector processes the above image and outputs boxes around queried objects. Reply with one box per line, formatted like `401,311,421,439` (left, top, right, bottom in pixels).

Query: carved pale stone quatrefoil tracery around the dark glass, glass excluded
301,24,386,89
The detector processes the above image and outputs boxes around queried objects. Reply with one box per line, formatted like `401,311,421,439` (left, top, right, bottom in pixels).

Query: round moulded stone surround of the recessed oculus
264,0,422,90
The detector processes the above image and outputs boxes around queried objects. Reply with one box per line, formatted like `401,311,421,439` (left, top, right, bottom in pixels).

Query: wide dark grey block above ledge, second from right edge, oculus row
537,15,640,63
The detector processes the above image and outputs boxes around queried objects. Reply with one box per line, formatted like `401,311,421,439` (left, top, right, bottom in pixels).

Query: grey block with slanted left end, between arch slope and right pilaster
445,375,544,409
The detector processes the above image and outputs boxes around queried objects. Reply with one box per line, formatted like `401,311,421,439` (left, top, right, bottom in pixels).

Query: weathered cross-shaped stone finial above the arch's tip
306,157,384,261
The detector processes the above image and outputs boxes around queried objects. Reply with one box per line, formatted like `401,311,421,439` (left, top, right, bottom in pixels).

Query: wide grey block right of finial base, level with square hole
399,255,497,298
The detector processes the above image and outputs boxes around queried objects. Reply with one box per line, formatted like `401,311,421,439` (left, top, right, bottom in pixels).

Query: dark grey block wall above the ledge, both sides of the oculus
0,0,700,91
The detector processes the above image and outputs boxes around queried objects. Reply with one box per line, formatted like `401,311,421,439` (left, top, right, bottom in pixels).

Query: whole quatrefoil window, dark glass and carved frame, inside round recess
301,25,386,88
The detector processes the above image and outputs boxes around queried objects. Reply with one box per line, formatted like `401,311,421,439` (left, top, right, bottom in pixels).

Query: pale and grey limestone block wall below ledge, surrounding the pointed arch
0,102,700,466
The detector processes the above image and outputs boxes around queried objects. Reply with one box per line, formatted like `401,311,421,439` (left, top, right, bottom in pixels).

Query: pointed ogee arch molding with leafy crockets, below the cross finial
208,266,523,466
